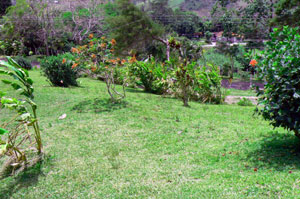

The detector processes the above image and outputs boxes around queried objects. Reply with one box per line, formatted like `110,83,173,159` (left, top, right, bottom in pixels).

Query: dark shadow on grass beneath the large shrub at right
248,132,300,171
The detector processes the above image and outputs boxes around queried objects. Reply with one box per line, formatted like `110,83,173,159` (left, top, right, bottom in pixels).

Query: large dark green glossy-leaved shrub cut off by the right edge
258,27,300,138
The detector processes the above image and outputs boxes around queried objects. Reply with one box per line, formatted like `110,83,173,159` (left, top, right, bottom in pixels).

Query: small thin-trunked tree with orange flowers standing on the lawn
71,34,126,102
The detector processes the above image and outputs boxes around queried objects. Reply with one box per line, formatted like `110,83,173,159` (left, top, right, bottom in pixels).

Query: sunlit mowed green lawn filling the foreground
0,71,300,199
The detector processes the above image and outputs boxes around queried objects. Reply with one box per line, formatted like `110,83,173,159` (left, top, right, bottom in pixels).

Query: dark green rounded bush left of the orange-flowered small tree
41,53,80,87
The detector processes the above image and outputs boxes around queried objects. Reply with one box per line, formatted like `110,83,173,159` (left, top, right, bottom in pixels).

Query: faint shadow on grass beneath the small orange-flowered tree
72,98,127,113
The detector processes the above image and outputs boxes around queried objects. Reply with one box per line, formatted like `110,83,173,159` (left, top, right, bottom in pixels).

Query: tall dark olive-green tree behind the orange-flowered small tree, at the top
107,0,163,54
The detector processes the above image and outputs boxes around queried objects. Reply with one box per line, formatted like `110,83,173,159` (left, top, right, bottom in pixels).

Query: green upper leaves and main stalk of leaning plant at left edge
0,57,43,154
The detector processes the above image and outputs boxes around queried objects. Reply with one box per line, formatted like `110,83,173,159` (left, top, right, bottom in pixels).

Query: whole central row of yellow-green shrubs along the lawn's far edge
129,58,224,106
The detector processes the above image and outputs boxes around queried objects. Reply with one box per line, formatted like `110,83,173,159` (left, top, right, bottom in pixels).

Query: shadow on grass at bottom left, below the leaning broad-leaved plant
0,156,51,199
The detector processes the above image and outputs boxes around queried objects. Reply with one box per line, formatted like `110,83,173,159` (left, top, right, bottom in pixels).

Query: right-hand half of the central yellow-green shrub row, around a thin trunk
169,59,224,106
